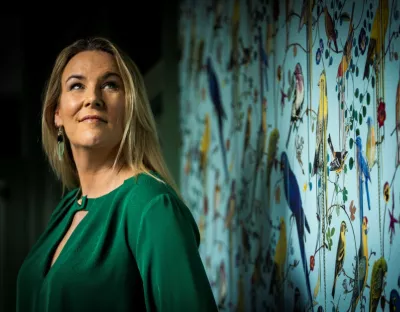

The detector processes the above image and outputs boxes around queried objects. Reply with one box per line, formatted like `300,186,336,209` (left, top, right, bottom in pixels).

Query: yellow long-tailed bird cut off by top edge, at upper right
363,0,389,79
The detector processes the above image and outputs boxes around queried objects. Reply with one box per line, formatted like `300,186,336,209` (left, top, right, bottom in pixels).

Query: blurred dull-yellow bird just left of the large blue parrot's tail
269,217,287,294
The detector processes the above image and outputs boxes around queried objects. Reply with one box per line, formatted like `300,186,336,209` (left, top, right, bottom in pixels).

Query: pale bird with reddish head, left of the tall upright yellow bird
286,63,305,148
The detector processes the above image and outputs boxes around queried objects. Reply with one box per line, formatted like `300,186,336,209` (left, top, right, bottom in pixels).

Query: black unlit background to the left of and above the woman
0,1,178,312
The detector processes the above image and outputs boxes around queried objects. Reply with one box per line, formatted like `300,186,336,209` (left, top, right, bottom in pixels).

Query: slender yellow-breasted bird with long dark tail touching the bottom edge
350,217,369,312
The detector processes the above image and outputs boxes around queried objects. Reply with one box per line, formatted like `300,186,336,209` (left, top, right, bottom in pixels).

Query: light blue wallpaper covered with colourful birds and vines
179,0,400,312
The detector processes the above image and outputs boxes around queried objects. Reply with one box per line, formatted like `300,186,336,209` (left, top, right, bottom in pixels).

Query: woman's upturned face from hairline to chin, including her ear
55,51,125,150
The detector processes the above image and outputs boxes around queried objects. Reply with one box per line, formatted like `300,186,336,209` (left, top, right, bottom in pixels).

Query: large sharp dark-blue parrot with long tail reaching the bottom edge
281,152,314,311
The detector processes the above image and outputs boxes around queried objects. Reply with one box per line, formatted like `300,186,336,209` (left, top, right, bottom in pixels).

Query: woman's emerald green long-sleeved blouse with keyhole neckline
17,174,217,312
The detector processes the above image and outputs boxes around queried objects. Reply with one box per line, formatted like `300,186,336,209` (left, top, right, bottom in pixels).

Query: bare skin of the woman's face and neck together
54,51,135,198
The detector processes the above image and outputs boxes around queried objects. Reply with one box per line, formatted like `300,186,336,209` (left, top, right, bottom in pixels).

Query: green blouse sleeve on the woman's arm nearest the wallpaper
135,194,218,312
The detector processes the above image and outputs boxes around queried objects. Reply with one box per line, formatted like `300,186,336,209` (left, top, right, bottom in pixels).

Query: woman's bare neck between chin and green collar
72,148,135,198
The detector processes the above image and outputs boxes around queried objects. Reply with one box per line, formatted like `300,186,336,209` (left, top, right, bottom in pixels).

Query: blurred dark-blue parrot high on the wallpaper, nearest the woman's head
206,57,229,179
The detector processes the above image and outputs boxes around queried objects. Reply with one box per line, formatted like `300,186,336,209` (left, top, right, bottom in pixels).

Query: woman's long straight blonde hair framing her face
42,37,180,197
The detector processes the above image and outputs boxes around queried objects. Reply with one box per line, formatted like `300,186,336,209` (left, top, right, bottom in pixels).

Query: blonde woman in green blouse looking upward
17,38,217,312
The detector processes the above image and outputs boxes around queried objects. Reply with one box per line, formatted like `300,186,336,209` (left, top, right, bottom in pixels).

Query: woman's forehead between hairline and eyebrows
62,51,119,80
